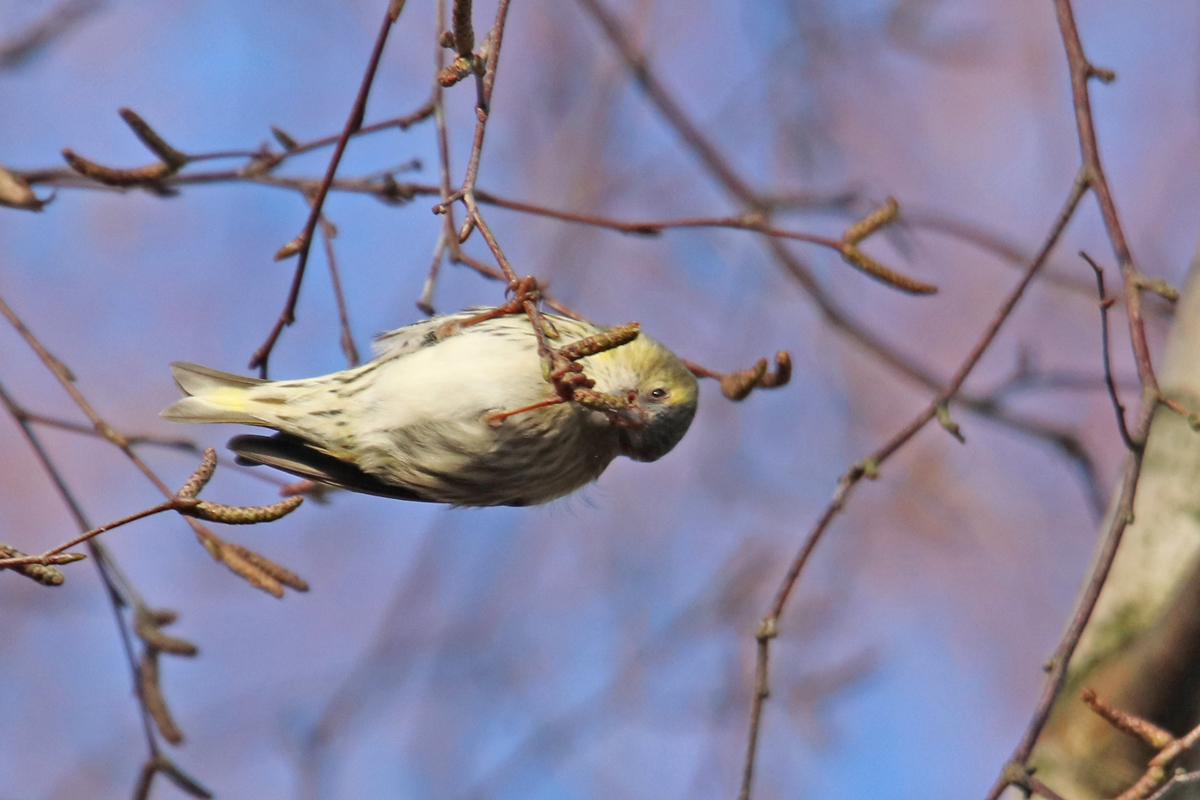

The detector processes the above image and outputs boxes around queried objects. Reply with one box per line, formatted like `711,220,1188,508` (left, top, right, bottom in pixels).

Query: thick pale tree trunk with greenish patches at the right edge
1031,235,1200,800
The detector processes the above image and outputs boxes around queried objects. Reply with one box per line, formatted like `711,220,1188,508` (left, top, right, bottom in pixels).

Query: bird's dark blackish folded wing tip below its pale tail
228,433,433,503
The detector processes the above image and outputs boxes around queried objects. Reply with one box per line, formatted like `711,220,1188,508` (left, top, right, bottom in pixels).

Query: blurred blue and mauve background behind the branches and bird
0,0,1200,800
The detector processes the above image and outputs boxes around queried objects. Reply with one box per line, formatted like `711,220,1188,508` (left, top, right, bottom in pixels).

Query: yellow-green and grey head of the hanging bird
582,333,700,462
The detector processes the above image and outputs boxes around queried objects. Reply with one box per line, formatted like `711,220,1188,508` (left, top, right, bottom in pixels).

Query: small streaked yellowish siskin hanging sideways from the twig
162,312,698,506
